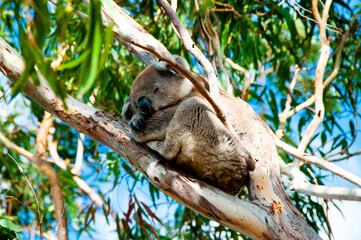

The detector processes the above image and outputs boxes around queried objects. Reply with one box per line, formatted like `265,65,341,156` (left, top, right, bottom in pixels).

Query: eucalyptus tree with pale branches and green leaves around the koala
0,0,361,239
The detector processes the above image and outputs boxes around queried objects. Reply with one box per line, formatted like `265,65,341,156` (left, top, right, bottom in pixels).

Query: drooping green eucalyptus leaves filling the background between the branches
0,0,361,239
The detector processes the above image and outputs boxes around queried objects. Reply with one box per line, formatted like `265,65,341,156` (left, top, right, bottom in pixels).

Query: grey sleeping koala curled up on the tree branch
122,56,255,195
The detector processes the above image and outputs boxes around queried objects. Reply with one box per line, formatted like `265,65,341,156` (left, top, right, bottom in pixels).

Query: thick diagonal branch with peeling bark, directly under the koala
0,35,319,239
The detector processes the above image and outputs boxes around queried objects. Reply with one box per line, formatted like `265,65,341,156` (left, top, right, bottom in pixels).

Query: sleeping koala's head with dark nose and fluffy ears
123,55,193,120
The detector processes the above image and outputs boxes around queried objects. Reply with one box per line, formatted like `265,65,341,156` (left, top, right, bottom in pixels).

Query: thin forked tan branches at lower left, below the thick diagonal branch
0,117,123,239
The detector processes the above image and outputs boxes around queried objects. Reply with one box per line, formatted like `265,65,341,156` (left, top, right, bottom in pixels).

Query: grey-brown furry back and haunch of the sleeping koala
167,97,251,195
